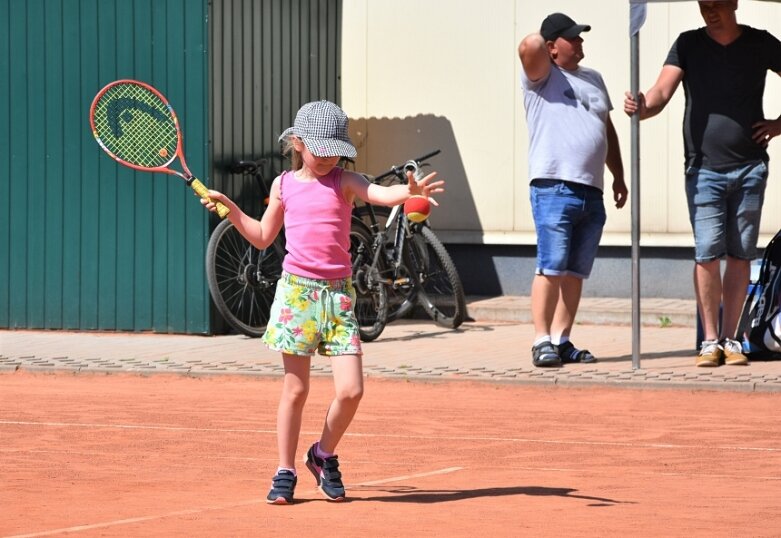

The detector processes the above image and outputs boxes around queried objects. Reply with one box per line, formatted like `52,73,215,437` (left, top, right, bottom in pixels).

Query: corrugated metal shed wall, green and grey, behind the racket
0,0,342,333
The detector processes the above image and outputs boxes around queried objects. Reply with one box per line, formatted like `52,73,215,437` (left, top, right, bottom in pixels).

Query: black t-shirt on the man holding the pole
664,25,781,170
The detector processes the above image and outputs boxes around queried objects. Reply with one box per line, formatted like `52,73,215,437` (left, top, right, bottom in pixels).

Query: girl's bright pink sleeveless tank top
280,167,352,280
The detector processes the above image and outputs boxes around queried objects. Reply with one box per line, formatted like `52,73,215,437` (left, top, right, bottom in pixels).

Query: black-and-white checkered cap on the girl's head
279,100,358,158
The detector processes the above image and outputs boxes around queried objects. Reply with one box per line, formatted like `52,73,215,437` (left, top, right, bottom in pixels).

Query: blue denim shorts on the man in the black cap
530,179,607,278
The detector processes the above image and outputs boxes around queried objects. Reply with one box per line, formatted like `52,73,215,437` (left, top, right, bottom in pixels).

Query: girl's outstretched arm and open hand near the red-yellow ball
342,170,445,206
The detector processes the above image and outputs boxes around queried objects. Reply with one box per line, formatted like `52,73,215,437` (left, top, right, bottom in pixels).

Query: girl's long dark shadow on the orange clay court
350,486,635,507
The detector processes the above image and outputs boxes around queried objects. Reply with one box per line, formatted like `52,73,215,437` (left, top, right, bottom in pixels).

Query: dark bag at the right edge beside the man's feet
737,230,781,358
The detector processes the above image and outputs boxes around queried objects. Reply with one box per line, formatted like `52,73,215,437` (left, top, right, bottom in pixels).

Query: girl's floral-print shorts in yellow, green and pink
263,273,361,355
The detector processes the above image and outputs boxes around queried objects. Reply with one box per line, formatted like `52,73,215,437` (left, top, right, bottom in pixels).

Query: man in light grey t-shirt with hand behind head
518,13,627,367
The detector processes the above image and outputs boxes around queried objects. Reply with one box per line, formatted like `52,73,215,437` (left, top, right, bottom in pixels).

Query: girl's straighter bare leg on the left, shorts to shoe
277,353,312,469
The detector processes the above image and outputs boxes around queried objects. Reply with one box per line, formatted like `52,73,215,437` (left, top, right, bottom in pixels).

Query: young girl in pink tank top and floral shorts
202,97,444,504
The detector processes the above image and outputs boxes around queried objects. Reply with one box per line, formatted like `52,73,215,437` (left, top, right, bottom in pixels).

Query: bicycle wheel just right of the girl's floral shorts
350,218,388,342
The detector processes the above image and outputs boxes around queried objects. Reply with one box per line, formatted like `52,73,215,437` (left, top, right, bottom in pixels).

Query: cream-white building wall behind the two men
342,0,781,246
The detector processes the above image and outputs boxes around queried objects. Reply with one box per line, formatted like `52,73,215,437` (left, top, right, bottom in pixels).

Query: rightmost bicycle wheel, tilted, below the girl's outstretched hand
404,224,466,329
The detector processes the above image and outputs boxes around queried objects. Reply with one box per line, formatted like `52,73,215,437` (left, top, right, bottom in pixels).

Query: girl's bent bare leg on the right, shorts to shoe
320,355,363,454
